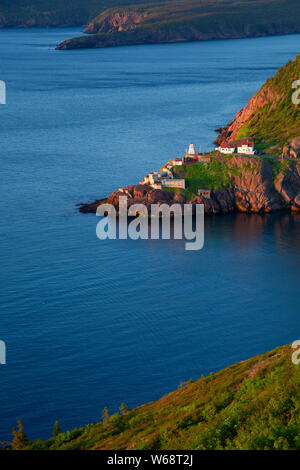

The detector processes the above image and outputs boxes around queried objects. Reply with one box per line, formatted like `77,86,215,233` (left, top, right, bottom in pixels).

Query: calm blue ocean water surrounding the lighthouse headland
0,29,300,439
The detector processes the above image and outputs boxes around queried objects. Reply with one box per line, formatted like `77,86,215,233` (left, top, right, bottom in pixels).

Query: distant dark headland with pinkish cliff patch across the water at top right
58,0,300,49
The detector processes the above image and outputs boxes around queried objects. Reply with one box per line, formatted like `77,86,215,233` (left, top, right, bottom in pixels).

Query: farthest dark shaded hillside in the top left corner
0,0,176,27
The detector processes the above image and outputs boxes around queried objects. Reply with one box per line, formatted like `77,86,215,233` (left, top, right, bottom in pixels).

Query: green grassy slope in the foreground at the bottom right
25,346,300,450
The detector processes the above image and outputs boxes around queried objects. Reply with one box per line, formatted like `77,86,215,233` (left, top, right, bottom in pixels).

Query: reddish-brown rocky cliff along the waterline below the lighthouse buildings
80,156,300,214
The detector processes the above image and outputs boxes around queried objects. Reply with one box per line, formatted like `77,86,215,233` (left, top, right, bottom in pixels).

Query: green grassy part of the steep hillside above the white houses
237,54,300,155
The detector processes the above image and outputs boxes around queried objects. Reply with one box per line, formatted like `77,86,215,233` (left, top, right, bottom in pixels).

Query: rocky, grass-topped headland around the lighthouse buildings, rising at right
80,54,300,214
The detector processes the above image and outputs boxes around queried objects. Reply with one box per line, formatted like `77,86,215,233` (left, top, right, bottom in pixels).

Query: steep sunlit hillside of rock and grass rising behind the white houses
216,54,300,157
